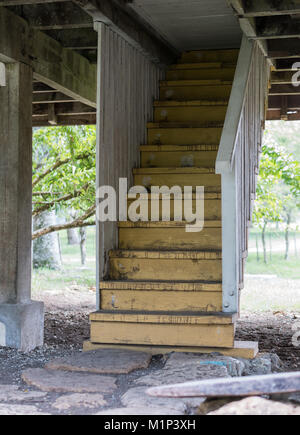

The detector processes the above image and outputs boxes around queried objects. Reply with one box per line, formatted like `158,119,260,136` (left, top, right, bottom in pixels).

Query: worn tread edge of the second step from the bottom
100,280,222,292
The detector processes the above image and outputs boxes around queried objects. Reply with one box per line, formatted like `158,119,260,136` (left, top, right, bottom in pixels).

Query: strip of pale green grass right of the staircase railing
246,253,300,279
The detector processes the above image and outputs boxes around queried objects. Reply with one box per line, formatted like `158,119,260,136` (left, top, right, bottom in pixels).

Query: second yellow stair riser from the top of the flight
166,68,235,81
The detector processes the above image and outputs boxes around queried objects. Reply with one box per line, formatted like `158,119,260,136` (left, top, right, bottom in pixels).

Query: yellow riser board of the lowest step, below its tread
91,322,234,348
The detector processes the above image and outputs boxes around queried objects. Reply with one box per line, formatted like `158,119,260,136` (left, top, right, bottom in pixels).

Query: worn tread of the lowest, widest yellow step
90,310,237,325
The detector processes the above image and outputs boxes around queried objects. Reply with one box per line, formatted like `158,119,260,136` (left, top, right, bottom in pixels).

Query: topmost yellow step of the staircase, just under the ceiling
178,49,239,63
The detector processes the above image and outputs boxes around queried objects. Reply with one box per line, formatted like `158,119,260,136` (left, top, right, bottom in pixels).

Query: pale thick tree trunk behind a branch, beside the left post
33,211,61,270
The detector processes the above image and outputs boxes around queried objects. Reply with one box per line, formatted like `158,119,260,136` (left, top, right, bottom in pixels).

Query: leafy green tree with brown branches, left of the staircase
32,126,96,240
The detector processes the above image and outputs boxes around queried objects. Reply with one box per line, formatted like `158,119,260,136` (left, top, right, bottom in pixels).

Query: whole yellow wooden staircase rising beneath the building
84,50,257,358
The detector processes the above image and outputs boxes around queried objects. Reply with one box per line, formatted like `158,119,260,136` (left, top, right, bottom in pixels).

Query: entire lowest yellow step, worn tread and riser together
90,311,235,348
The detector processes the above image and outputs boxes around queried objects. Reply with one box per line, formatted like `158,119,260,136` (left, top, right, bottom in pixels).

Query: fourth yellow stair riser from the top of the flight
154,106,227,123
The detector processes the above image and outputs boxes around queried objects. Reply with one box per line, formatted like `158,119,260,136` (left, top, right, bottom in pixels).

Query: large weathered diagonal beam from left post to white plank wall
0,7,97,107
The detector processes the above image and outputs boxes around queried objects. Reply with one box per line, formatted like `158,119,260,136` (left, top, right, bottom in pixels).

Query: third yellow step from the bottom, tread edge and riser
109,251,222,282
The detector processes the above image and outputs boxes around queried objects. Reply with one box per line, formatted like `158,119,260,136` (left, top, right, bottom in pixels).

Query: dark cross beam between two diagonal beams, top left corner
10,2,93,30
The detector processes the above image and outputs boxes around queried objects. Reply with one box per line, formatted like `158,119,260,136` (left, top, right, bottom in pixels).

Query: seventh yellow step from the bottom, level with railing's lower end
140,145,219,168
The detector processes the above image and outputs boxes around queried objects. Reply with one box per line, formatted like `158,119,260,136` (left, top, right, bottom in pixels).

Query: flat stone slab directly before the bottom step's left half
45,349,151,374
